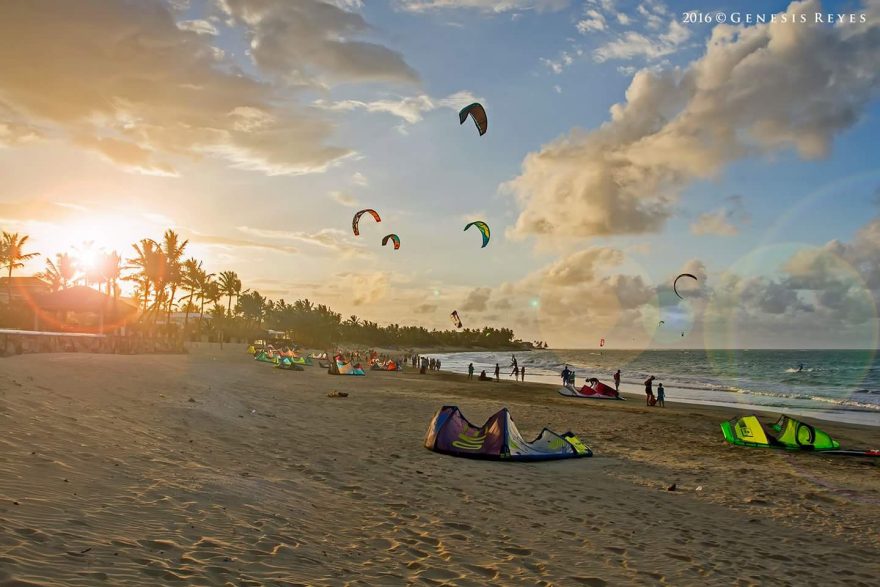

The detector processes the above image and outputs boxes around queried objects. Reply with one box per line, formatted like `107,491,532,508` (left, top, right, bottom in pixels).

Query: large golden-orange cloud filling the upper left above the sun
0,0,349,174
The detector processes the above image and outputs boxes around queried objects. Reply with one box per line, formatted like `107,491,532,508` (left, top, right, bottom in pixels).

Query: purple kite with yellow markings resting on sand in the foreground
425,406,593,461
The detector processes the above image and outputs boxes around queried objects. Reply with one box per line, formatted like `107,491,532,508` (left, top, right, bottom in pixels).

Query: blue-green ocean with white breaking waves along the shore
432,350,880,426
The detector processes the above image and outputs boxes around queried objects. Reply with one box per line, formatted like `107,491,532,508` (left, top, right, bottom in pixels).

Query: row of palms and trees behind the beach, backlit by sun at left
0,229,546,349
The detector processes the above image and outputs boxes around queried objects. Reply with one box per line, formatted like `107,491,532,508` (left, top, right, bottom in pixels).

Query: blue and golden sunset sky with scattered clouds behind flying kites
0,0,880,349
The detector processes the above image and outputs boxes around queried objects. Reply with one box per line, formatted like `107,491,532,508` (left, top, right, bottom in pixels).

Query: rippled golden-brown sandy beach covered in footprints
0,345,880,587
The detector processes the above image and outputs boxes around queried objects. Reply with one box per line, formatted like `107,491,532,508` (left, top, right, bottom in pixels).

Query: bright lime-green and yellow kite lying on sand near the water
721,415,840,451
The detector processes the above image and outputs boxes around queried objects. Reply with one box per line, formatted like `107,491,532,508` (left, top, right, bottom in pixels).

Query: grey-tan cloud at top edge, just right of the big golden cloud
221,0,418,85
